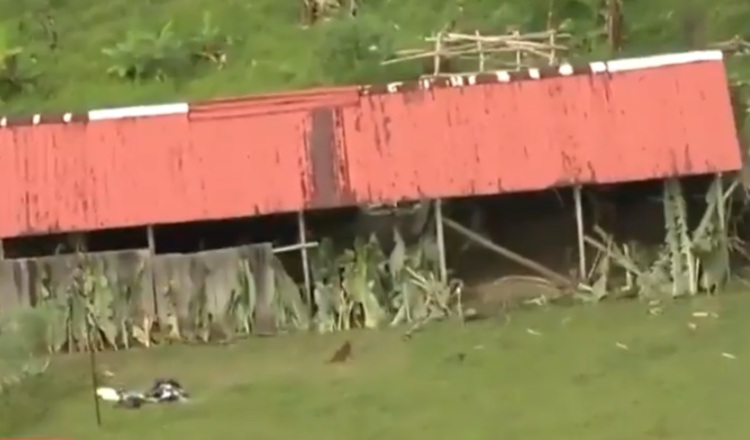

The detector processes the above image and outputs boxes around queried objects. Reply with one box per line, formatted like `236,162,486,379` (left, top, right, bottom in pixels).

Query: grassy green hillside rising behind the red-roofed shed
0,0,750,114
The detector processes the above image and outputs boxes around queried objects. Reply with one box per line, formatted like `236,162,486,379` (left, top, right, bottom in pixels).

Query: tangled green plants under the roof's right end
580,176,748,304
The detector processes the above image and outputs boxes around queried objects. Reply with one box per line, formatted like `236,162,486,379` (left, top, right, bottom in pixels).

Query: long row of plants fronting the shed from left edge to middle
0,231,461,358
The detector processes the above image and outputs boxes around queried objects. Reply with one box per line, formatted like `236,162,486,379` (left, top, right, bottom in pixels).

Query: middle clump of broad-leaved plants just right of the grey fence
312,229,462,332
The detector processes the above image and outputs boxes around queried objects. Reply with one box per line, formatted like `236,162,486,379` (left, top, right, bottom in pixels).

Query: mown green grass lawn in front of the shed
0,295,750,440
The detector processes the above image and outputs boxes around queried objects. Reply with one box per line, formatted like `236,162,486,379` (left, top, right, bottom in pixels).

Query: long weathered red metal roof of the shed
0,51,741,237
